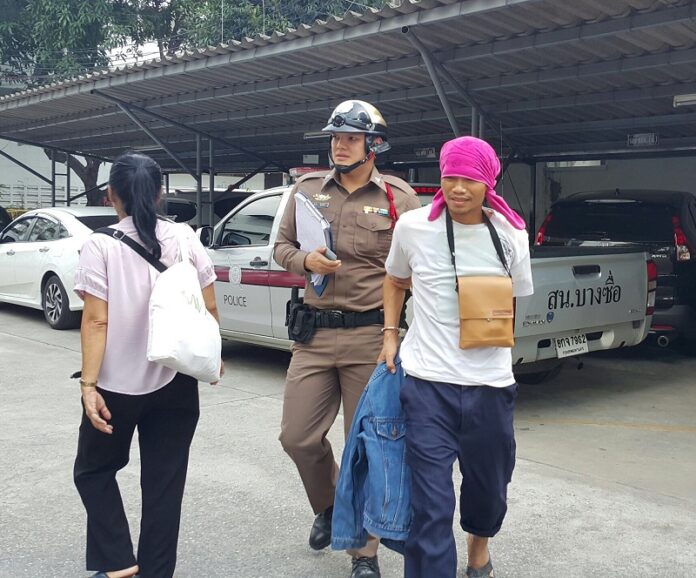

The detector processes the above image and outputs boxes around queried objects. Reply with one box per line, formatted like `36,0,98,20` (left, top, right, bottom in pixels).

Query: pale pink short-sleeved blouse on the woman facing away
75,217,215,395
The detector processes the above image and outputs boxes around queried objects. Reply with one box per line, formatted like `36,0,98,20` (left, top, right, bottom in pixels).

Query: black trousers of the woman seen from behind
73,373,200,578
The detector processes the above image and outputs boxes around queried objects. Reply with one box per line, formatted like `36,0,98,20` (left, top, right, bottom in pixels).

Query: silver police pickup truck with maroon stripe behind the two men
199,187,657,383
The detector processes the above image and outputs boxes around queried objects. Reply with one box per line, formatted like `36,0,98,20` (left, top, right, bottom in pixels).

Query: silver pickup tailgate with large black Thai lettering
513,247,648,363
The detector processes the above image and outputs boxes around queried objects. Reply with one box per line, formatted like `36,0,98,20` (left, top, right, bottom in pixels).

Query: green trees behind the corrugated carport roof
0,0,386,204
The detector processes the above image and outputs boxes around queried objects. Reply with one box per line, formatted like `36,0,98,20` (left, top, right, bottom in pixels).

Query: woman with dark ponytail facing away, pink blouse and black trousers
74,153,218,578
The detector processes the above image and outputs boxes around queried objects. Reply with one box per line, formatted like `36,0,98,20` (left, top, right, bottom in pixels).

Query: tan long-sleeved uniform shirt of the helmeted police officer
274,169,420,311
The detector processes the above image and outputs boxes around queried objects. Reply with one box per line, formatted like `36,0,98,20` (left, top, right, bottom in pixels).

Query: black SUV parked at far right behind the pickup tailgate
535,189,696,346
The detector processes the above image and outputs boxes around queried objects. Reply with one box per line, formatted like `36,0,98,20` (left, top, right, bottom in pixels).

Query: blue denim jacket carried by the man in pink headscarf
331,359,411,553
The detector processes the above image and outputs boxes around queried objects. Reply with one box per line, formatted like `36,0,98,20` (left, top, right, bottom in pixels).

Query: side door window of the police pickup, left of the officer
218,195,282,247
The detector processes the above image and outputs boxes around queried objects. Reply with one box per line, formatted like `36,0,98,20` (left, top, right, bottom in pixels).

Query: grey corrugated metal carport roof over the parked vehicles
0,0,696,171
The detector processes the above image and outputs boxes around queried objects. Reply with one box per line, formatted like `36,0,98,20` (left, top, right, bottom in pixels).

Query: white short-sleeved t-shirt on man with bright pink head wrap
385,206,534,387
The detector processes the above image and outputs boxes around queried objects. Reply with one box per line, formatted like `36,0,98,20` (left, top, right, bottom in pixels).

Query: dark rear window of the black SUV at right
545,201,674,243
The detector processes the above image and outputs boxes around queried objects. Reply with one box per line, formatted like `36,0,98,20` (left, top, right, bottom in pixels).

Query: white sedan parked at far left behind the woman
0,207,118,329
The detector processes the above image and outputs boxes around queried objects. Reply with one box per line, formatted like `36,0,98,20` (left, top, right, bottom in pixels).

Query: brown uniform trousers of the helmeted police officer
280,325,382,514
